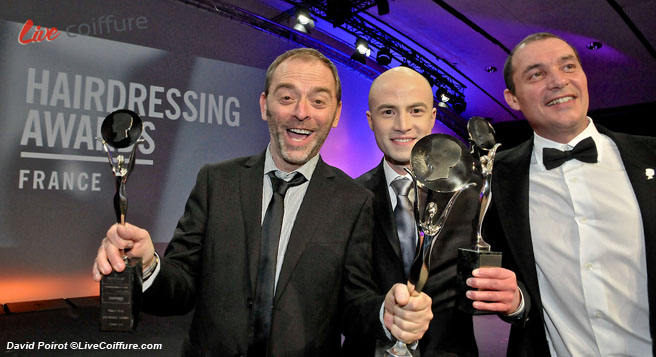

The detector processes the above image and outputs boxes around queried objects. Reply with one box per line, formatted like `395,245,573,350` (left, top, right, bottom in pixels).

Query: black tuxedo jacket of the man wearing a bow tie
486,126,656,356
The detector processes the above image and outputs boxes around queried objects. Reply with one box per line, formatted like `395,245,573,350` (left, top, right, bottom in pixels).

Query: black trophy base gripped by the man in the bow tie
456,248,501,315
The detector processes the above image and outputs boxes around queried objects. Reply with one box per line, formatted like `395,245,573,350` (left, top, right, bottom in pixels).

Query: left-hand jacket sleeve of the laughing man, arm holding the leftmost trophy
143,166,210,315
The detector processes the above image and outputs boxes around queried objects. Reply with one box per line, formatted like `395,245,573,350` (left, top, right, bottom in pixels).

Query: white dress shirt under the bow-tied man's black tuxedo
529,120,652,356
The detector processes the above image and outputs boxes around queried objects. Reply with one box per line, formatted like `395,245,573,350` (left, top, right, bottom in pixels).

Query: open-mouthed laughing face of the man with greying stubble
260,56,342,172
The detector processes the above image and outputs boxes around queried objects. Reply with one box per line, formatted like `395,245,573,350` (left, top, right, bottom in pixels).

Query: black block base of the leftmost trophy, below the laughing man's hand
100,258,143,332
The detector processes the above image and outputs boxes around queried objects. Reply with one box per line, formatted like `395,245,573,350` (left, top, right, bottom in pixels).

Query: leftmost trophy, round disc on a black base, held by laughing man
96,109,143,331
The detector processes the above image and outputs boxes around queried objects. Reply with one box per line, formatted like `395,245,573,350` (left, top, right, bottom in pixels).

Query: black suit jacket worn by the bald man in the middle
344,161,478,356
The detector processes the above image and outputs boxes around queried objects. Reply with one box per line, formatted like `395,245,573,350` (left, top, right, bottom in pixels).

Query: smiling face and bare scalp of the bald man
367,67,436,174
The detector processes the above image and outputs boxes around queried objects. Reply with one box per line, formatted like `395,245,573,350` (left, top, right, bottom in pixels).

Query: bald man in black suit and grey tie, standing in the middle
343,67,478,356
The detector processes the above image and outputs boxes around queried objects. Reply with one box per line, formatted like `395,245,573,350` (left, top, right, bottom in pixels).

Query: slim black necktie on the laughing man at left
248,171,306,356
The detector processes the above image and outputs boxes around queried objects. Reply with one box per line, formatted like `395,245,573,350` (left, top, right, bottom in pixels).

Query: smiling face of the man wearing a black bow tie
504,38,589,143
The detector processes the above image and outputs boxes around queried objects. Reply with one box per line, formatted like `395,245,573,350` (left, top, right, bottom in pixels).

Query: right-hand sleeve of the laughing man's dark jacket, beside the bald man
341,192,385,339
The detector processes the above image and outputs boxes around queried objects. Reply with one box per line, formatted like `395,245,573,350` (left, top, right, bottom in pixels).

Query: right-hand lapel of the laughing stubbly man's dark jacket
273,157,335,305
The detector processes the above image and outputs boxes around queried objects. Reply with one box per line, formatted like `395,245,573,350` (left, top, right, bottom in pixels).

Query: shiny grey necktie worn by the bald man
392,179,417,277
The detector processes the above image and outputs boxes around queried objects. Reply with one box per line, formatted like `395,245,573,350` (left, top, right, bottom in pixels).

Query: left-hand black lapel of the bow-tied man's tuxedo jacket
492,138,539,297
